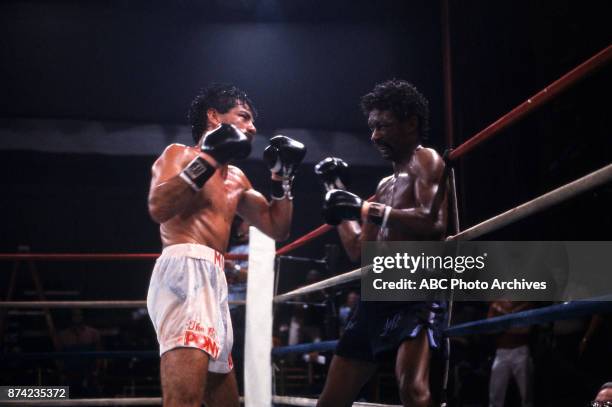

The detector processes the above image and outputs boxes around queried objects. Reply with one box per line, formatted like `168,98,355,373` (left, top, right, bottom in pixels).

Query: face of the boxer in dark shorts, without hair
368,109,418,161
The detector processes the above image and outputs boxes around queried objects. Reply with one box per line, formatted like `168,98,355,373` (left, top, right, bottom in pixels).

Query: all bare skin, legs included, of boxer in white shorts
149,103,293,407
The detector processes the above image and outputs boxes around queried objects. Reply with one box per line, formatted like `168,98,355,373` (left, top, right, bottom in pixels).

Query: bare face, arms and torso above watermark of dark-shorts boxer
338,110,447,261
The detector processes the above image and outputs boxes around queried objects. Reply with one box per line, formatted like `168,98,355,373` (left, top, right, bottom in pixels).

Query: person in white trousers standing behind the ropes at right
488,300,533,407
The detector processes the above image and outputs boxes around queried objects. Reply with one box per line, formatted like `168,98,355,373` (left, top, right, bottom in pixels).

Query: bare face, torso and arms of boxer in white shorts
149,104,293,252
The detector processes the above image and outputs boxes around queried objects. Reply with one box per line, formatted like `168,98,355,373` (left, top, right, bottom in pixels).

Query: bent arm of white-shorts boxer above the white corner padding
237,174,293,241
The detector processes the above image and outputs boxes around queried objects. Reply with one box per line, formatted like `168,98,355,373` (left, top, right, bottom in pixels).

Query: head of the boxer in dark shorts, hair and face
361,79,429,160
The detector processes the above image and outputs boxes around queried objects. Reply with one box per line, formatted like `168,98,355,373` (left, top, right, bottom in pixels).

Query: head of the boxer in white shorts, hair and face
189,83,257,144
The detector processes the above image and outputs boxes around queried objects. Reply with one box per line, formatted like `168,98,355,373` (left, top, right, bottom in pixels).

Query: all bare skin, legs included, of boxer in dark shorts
317,109,447,407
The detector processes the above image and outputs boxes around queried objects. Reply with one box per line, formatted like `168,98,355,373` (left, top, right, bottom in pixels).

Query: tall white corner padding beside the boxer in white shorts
244,226,276,407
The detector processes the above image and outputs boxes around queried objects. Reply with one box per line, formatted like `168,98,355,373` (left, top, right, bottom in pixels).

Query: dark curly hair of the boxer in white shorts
187,83,257,143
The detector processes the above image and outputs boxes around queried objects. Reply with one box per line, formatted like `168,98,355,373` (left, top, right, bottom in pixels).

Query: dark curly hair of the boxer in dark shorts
361,79,429,139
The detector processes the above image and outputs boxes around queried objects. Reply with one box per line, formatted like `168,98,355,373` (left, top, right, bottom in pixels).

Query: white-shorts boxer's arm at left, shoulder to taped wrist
148,144,215,223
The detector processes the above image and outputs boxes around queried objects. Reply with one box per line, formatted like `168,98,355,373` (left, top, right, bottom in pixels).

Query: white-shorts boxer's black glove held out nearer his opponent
263,136,306,179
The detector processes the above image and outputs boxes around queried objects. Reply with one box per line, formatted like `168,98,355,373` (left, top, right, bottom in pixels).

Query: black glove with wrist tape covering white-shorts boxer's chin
179,123,251,192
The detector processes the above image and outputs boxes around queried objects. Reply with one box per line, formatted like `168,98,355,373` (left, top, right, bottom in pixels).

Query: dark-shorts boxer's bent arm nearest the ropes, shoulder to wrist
364,149,447,236
